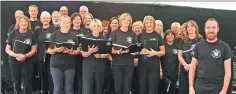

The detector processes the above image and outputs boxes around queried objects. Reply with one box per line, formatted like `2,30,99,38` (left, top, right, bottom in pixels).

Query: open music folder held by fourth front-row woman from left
113,43,142,53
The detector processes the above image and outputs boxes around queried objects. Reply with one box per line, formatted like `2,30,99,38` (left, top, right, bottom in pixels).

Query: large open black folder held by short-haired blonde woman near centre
80,37,112,54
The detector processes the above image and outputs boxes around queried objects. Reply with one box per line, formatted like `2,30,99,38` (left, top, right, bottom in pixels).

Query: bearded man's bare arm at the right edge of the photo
221,58,231,92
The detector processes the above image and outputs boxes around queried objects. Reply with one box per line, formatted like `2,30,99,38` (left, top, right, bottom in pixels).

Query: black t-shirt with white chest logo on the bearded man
191,39,233,83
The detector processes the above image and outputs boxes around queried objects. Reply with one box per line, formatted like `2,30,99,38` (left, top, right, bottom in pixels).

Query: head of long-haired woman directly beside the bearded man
186,20,200,38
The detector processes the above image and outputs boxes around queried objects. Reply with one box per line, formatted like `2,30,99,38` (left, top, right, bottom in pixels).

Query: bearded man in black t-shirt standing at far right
189,18,233,94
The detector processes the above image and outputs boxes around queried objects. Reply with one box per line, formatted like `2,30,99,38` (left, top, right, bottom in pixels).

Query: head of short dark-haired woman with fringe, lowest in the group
164,29,175,42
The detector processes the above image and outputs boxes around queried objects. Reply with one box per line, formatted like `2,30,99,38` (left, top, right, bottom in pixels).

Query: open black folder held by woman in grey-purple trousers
44,41,75,49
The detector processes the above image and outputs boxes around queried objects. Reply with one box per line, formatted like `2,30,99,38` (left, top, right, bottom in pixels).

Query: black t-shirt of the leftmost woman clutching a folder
6,29,37,63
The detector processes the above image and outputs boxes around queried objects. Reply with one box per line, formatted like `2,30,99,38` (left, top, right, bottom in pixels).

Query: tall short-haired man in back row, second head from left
29,5,41,32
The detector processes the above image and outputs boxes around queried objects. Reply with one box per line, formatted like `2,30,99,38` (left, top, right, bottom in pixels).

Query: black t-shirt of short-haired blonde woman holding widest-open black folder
83,34,106,71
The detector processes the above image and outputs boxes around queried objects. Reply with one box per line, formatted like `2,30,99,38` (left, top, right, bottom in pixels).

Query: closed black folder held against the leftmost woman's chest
13,40,31,54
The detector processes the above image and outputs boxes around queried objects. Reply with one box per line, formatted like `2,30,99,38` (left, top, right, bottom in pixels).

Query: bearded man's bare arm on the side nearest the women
189,57,197,89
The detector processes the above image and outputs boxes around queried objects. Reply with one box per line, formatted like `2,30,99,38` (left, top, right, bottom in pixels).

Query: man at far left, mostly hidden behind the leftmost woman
7,10,24,36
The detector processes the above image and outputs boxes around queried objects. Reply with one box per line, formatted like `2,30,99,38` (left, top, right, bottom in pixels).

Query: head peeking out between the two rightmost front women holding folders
132,21,143,35
